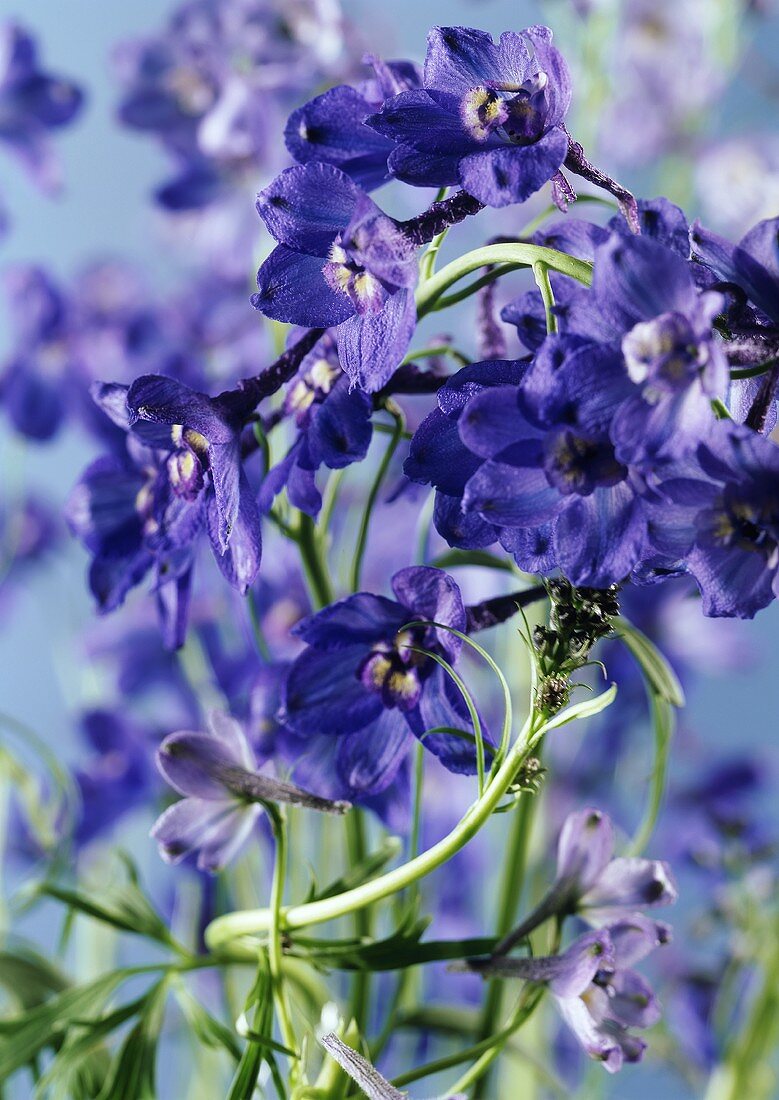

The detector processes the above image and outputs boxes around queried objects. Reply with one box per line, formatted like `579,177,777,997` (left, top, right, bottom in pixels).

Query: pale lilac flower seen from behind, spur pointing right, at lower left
152,711,349,872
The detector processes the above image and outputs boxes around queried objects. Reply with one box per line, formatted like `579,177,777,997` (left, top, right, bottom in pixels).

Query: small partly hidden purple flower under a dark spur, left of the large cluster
260,334,373,516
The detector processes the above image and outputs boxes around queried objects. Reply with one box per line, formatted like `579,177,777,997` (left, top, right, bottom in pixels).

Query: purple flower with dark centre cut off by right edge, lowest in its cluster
647,420,779,618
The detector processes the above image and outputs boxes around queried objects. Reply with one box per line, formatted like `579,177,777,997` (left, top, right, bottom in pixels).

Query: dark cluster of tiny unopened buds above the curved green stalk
533,579,619,714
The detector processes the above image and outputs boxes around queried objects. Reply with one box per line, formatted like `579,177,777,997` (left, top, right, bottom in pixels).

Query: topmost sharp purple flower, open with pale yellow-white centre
367,26,571,207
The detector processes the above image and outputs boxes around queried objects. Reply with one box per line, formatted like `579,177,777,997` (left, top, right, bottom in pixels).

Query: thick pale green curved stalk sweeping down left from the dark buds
206,686,616,950
